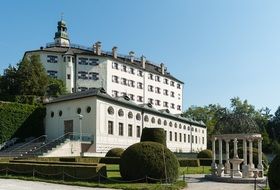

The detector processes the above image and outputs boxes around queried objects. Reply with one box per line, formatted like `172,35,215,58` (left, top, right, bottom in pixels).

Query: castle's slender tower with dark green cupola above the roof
54,19,70,47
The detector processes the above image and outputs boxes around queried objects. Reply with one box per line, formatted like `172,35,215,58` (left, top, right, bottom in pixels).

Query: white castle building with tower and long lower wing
24,20,207,156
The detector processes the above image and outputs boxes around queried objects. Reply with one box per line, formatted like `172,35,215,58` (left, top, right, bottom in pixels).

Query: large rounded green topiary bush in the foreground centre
120,142,179,182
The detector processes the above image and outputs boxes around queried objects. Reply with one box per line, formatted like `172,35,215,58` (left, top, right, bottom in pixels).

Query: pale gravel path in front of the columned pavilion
185,174,254,190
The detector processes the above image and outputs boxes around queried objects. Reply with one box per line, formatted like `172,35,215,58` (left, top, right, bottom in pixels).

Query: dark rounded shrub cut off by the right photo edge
267,154,280,190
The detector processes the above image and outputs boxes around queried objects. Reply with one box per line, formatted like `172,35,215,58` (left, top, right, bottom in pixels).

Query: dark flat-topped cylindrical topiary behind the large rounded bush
140,128,166,146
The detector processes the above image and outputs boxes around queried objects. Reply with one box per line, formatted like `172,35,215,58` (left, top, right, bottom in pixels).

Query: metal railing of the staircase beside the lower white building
29,133,94,156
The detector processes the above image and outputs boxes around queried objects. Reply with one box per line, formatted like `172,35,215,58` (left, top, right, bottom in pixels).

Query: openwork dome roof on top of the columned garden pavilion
214,114,259,134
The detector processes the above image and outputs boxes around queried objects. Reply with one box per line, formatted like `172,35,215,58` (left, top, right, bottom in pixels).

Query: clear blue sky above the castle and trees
0,0,280,113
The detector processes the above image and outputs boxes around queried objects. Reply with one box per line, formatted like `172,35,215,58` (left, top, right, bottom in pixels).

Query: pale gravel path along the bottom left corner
0,179,114,190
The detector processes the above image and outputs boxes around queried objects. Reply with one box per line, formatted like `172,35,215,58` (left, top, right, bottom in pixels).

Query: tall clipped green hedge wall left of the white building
0,102,46,143
